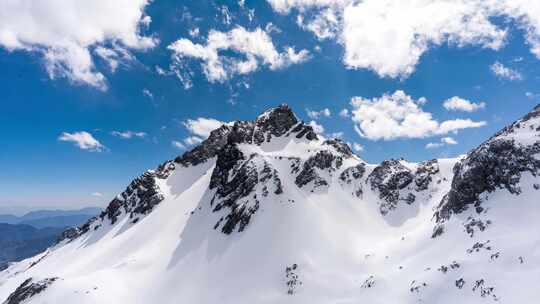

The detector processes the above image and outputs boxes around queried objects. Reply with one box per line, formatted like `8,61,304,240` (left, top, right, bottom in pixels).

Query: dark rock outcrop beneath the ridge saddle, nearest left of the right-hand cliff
367,159,415,215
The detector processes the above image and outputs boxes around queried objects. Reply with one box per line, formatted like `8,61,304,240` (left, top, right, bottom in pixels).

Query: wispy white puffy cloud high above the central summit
168,26,309,83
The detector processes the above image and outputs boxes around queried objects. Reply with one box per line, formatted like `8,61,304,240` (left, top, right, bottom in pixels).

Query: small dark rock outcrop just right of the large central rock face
294,151,343,188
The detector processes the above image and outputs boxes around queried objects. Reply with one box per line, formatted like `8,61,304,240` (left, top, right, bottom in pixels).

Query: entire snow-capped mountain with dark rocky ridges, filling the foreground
0,105,540,304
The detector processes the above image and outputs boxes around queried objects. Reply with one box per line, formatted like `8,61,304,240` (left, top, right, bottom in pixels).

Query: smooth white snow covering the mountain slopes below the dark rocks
0,115,540,304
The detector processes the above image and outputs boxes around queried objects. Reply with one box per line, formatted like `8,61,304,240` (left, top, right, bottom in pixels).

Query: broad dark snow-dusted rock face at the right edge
435,138,540,222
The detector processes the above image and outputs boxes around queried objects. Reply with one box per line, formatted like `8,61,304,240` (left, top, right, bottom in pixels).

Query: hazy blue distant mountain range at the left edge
0,207,101,270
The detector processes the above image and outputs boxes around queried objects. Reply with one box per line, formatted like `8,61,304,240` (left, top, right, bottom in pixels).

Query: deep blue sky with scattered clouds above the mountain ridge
0,0,540,208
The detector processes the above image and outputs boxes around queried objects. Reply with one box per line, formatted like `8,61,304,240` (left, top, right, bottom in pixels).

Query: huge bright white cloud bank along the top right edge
267,0,540,78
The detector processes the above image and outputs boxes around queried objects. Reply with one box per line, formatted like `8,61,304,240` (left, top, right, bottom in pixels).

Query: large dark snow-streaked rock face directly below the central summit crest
210,145,283,234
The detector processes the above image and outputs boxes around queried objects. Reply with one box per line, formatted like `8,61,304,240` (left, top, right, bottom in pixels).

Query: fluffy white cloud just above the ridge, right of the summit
351,91,486,140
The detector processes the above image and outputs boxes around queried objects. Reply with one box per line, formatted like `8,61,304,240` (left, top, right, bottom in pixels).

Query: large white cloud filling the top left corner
0,0,157,90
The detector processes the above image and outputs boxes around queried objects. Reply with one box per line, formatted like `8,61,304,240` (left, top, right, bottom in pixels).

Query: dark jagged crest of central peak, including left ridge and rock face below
59,104,318,242
